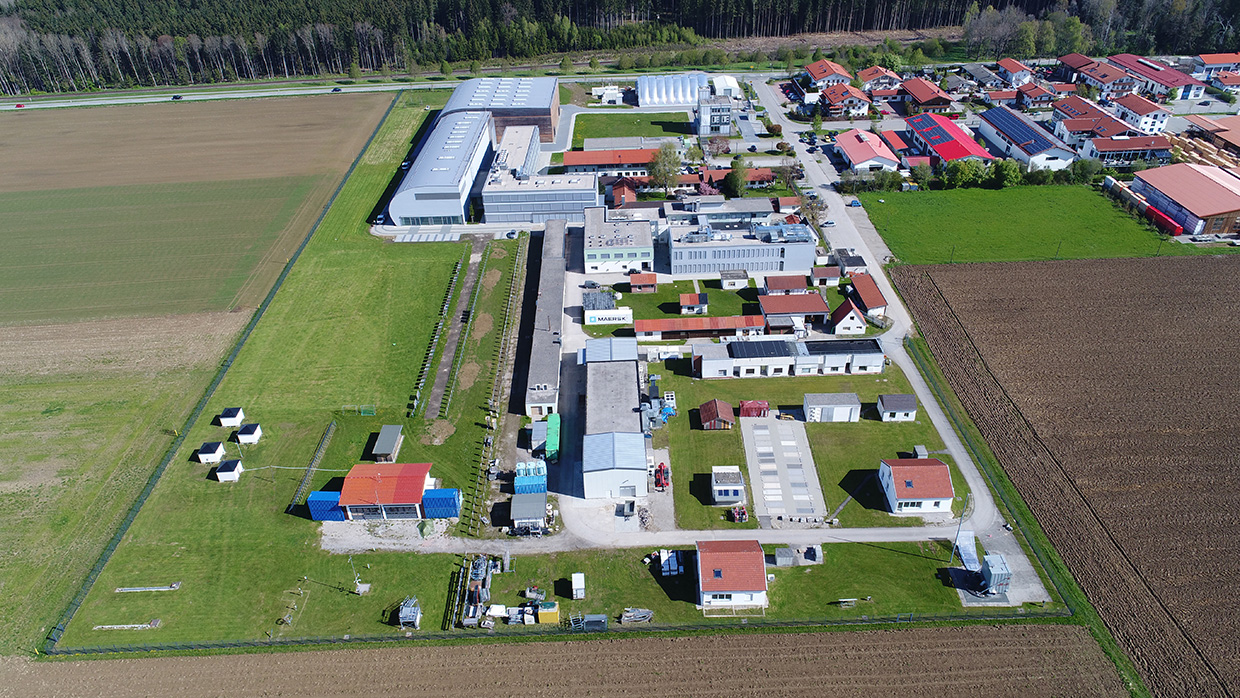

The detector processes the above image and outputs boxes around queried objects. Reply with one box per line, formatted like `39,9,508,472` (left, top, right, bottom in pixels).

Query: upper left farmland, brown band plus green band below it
0,94,392,325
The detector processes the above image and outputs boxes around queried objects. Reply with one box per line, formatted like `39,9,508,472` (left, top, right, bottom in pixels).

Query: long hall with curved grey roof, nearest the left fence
388,112,495,226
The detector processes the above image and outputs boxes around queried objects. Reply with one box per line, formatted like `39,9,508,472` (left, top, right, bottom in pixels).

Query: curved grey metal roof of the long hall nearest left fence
393,112,495,197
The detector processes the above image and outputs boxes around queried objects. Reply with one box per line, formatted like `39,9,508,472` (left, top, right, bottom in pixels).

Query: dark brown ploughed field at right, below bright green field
894,257,1240,696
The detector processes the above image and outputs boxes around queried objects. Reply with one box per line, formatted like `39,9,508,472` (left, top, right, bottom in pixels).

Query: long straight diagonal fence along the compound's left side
42,89,404,653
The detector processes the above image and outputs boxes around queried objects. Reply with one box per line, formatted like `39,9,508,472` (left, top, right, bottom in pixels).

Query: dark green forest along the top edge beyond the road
0,0,1240,94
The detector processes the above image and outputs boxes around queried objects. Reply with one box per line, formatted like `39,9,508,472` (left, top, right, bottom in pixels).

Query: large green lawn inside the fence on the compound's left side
55,89,517,645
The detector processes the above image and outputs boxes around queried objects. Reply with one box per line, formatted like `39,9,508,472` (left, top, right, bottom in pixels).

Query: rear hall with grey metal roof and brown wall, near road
439,77,559,143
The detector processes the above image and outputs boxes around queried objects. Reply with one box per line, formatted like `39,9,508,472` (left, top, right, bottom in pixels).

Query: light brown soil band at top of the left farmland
0,93,392,190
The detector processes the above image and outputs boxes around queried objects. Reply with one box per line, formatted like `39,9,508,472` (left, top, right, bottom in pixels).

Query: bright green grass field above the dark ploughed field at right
858,186,1230,264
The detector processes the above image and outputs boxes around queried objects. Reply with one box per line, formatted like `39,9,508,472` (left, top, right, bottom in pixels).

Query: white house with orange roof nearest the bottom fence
697,541,768,611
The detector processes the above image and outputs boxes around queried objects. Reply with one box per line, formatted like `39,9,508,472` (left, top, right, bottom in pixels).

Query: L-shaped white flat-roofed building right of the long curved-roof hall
482,125,601,223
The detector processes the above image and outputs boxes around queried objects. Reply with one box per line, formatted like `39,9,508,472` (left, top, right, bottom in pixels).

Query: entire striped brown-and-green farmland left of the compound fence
0,95,391,652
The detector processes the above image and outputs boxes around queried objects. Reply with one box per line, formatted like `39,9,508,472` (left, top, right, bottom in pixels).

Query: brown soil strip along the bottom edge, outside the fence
0,625,1127,698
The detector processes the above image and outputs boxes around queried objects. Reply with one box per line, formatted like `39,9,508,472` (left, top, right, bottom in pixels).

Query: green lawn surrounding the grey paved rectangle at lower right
650,360,967,528
